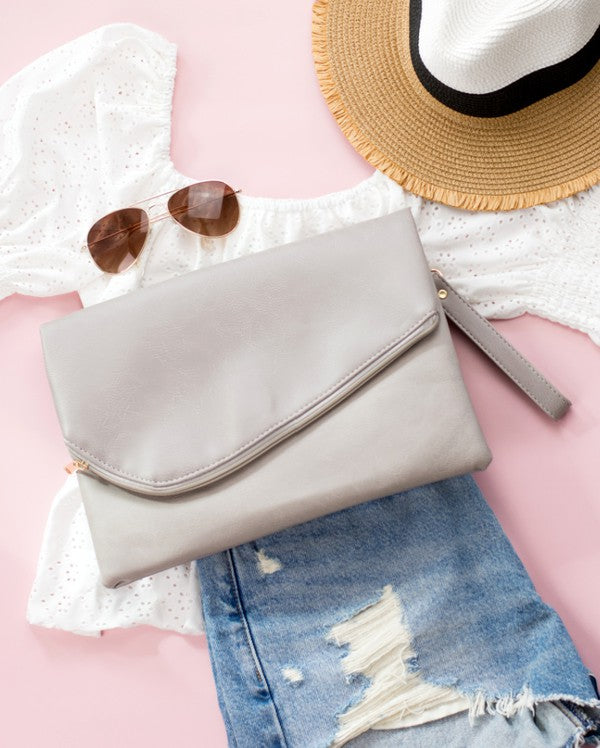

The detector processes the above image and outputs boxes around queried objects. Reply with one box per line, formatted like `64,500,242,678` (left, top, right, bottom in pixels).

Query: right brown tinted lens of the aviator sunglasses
169,182,240,236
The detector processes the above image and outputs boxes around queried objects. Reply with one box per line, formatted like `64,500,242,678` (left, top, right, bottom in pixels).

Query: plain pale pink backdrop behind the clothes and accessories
0,0,600,748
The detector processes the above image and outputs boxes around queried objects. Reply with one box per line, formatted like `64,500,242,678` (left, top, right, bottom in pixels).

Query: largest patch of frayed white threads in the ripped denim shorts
328,585,469,748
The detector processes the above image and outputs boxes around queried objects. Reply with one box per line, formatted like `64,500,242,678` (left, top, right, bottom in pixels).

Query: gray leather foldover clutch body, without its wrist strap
41,209,491,587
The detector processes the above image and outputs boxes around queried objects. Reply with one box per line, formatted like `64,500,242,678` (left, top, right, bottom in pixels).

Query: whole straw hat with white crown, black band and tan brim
313,0,600,210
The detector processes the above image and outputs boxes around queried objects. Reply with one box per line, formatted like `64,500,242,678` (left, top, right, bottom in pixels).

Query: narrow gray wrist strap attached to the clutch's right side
432,270,571,420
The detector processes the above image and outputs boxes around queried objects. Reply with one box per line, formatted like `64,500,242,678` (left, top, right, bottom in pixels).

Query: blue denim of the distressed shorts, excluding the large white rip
197,476,600,748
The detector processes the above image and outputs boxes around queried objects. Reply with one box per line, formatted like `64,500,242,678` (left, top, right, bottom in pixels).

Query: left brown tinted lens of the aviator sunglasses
87,208,148,273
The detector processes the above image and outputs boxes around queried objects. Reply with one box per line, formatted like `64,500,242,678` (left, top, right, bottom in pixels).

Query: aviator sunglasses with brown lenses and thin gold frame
84,181,240,273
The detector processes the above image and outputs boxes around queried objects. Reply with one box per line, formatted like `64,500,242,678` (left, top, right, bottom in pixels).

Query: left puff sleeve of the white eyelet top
0,23,176,298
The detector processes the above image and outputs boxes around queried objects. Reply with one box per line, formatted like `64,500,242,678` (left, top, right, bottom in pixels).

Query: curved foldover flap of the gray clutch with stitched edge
42,209,440,496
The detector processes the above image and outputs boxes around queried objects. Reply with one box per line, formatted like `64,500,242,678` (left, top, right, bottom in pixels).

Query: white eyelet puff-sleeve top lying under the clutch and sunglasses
0,23,600,634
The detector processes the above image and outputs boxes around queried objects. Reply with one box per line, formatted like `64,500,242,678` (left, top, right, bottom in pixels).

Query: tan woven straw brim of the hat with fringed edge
313,0,600,210
